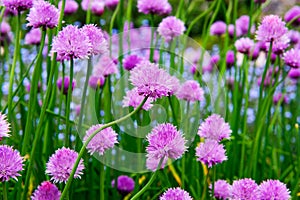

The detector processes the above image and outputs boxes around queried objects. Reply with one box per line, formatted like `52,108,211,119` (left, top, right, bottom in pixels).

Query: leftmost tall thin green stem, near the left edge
8,12,21,120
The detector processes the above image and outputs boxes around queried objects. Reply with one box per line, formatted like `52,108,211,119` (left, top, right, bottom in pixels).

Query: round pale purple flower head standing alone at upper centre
157,16,185,42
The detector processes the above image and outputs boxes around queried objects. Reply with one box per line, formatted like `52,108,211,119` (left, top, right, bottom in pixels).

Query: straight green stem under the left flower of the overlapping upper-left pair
63,58,74,147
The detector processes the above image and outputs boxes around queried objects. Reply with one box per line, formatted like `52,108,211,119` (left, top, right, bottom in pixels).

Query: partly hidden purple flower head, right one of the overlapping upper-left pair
82,24,108,55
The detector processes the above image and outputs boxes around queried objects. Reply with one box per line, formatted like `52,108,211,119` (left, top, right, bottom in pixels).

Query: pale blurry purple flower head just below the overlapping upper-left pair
93,55,119,77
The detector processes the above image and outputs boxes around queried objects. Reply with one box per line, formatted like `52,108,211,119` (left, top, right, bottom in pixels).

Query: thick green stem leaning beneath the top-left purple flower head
22,29,46,155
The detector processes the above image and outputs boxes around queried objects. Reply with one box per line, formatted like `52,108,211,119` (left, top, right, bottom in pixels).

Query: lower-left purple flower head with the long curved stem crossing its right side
46,147,84,183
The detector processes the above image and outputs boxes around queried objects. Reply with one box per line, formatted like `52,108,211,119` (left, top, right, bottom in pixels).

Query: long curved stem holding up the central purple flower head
60,97,148,200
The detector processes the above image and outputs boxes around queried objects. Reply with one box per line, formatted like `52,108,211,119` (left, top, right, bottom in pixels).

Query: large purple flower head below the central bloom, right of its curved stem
146,123,187,170
